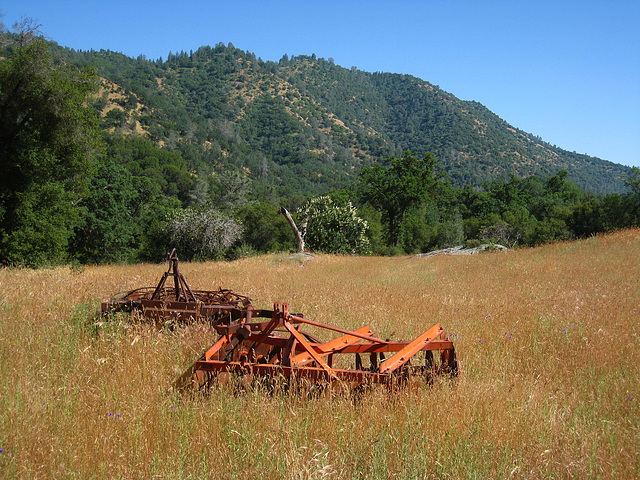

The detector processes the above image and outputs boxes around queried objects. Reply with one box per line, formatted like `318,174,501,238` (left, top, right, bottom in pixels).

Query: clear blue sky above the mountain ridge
0,0,640,166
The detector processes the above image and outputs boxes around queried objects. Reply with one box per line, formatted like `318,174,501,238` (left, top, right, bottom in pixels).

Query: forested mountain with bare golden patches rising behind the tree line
59,44,630,197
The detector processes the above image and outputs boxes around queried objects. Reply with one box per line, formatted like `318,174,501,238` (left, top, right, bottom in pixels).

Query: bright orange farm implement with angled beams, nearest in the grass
176,303,459,389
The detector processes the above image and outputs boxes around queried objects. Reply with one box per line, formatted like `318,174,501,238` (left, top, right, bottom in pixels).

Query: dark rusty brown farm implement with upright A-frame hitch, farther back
100,249,251,323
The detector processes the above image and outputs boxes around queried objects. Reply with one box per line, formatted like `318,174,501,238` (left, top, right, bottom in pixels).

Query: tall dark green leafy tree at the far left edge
0,22,100,265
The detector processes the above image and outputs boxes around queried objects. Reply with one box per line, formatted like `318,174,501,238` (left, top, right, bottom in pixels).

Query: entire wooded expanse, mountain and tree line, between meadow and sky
0,24,640,266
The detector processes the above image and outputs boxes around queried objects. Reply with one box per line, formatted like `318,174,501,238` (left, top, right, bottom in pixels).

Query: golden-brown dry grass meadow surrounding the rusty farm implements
0,229,640,479
